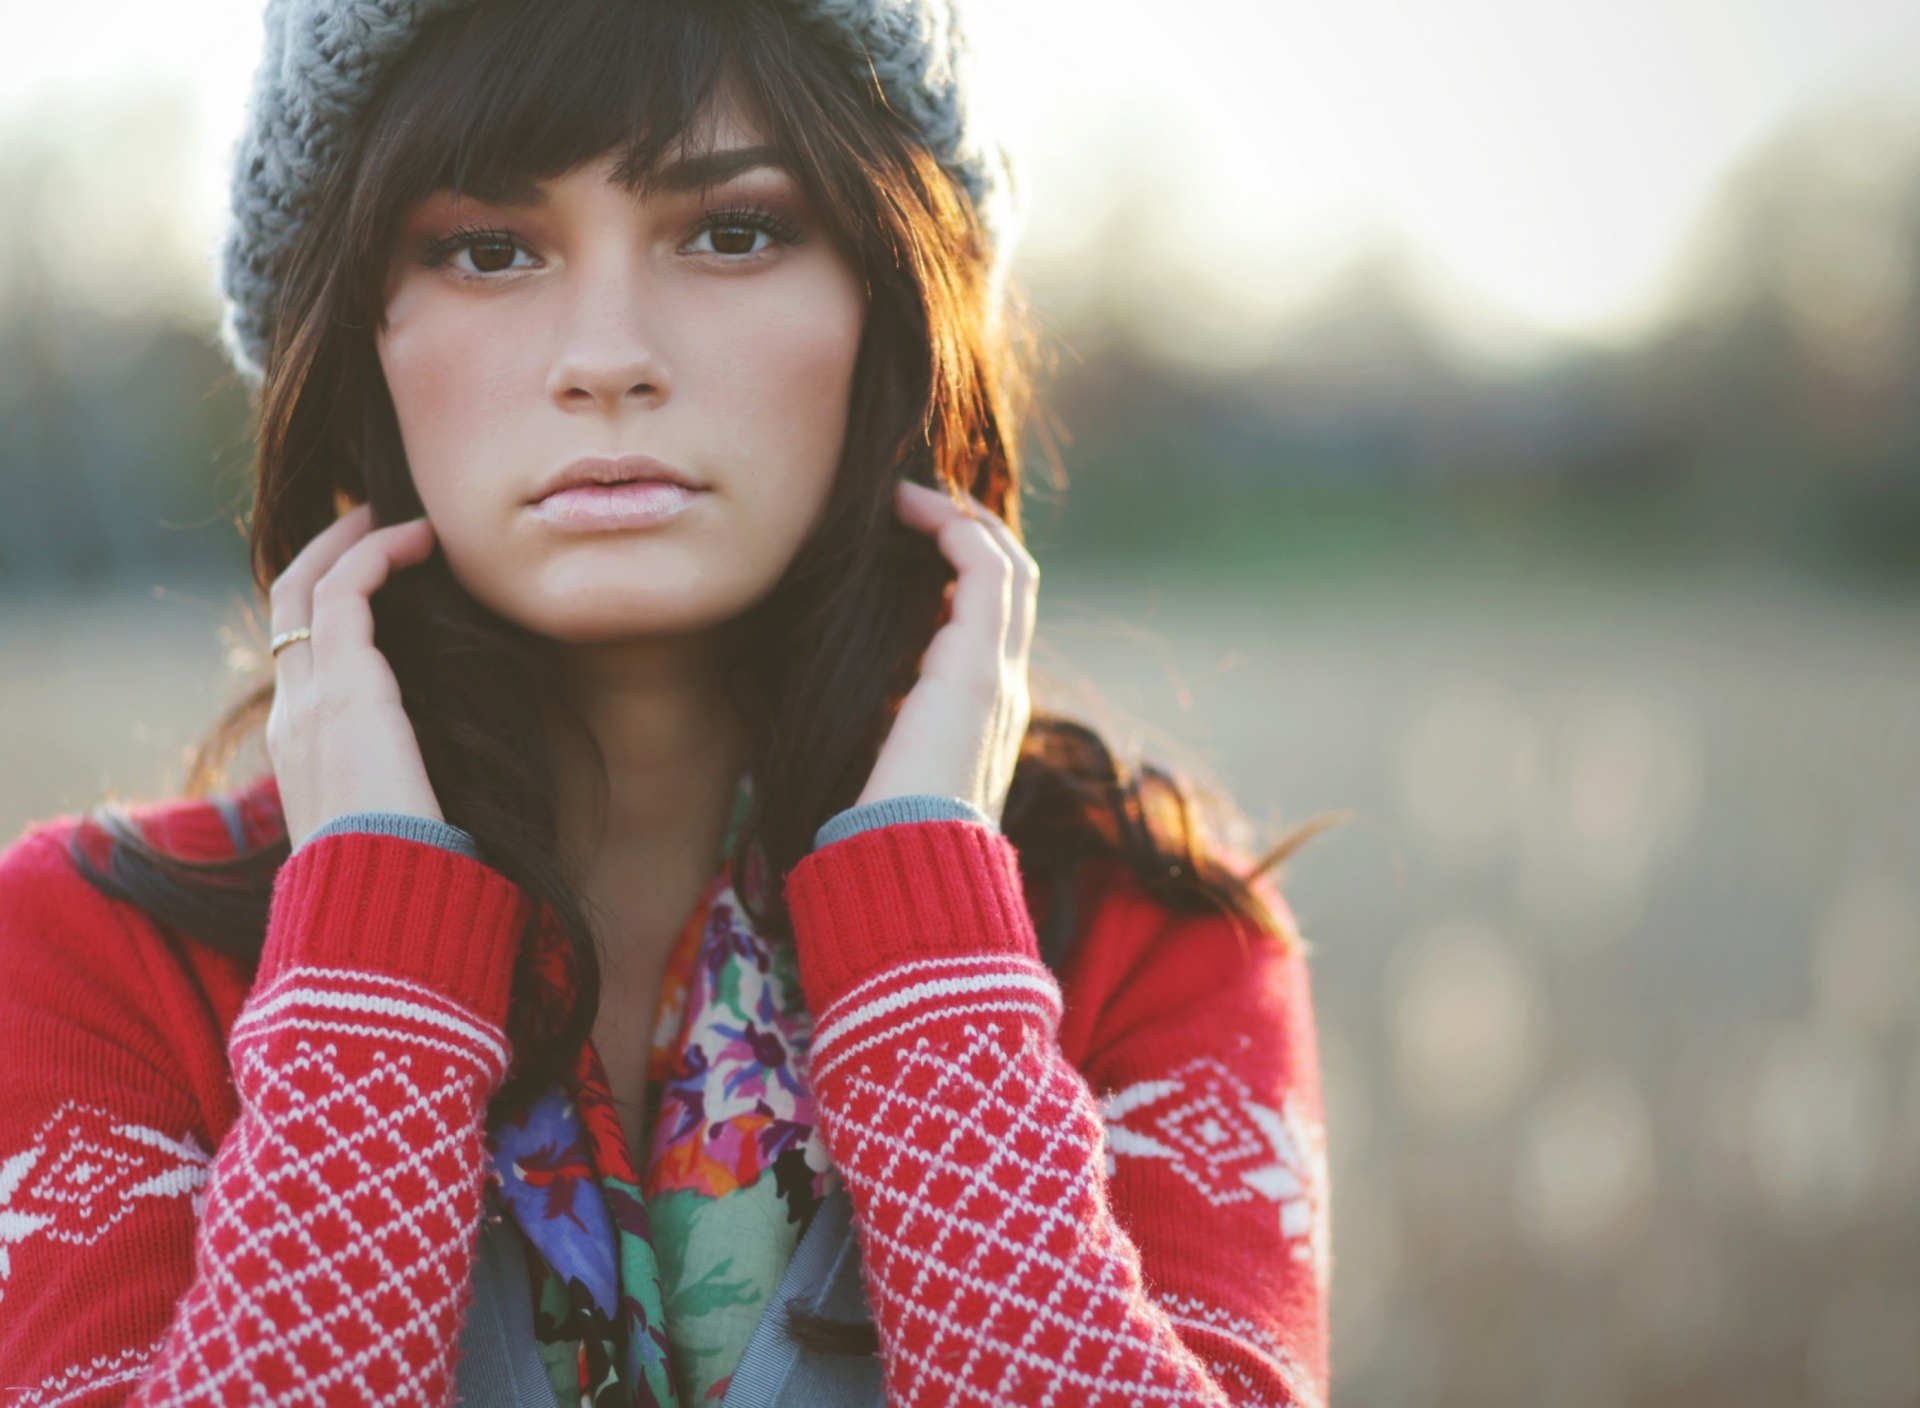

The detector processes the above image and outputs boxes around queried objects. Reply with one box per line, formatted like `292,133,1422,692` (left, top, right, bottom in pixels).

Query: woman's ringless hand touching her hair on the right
860,482,1041,824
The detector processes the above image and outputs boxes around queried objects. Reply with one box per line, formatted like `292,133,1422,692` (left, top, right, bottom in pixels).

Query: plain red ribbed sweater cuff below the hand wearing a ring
257,832,526,1026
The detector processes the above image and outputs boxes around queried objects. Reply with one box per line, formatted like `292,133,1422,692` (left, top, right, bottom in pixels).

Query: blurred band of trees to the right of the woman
1035,108,1920,570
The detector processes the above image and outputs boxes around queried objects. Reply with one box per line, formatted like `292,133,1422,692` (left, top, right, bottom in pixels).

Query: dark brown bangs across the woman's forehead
322,0,898,321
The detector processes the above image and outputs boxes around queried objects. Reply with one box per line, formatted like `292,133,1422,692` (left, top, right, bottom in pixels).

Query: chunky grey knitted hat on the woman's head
221,0,1010,376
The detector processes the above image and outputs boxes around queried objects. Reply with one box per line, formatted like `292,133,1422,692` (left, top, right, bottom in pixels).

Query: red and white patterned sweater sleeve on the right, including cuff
787,822,1325,1406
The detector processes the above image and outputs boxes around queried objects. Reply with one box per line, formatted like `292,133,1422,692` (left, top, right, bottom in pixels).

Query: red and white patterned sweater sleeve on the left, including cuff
0,822,526,1404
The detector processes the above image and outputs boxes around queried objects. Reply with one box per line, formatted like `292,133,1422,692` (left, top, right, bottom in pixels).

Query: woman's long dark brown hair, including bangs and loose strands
75,0,1277,1106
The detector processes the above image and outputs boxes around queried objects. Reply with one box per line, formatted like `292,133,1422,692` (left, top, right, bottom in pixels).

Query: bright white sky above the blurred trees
0,0,1920,334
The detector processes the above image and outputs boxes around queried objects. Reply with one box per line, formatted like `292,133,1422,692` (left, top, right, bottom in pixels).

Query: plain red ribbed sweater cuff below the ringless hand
787,822,1039,1012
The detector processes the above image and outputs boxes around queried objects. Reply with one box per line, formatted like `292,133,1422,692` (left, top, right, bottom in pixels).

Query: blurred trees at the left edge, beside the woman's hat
0,100,248,586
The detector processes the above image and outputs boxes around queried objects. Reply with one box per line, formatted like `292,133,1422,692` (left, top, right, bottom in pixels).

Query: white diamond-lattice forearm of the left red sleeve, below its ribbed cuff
136,970,505,1406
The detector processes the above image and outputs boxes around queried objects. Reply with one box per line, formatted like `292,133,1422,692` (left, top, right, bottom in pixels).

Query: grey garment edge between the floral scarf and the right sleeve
720,1187,887,1408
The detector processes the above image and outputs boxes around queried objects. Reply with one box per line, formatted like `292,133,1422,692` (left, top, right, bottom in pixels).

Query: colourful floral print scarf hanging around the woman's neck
488,872,831,1408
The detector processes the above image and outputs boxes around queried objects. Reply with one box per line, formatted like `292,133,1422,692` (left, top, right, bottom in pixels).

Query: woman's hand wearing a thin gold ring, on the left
267,505,445,845
